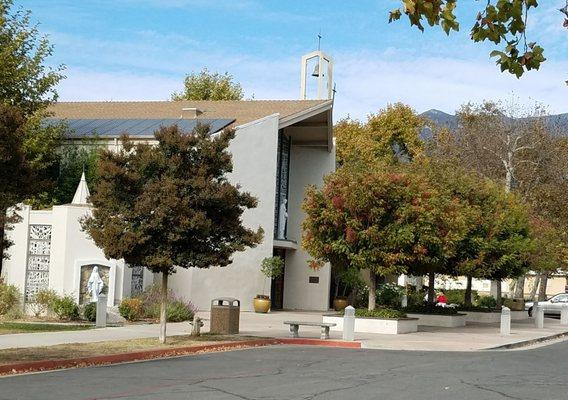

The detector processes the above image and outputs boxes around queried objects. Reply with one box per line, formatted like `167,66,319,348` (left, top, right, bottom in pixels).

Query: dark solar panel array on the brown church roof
43,118,235,138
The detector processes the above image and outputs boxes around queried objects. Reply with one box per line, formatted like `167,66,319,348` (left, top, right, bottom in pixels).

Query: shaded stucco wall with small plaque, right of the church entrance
284,144,335,310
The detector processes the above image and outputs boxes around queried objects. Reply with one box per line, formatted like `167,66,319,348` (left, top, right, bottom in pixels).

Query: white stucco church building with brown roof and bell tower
2,51,335,310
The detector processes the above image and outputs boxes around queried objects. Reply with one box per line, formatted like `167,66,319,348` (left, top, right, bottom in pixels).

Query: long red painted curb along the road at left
0,339,281,375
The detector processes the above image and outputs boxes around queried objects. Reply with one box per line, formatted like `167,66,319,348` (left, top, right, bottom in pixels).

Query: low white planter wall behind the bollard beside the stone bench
323,316,418,335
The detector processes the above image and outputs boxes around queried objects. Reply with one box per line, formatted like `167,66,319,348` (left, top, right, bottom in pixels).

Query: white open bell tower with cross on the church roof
300,35,333,100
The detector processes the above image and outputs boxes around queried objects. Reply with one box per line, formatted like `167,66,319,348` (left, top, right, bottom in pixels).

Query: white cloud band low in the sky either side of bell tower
54,43,568,118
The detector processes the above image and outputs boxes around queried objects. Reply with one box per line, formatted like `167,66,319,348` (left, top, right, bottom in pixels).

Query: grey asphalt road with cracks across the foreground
0,342,568,400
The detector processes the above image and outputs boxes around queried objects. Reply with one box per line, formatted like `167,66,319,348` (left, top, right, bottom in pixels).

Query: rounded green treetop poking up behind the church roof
172,68,243,101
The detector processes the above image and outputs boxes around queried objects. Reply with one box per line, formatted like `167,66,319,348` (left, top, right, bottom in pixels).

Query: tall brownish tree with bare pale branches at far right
428,102,568,298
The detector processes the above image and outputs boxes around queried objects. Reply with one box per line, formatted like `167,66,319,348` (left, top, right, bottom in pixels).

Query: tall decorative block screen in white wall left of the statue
25,225,51,302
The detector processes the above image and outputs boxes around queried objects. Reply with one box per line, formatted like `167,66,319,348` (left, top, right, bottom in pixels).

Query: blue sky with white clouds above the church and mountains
15,0,568,118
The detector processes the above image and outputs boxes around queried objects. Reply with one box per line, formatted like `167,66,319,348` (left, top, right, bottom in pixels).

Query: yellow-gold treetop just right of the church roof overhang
333,103,428,164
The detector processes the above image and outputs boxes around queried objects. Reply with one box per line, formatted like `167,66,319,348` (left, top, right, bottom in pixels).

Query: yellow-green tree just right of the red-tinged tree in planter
420,158,531,305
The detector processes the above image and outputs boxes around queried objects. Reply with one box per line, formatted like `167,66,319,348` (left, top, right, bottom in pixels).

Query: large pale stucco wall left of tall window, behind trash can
169,115,278,311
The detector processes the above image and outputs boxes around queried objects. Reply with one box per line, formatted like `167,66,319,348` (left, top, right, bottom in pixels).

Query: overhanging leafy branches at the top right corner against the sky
389,0,552,78
